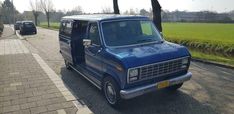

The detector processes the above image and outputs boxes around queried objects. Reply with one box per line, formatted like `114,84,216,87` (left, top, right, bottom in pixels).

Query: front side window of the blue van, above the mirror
88,23,100,45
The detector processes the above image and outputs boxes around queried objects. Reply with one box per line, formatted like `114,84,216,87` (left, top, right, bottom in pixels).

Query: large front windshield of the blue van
102,20,163,46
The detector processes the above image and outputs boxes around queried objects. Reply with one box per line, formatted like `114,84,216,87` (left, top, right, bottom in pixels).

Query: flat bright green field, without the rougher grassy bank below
163,23,234,45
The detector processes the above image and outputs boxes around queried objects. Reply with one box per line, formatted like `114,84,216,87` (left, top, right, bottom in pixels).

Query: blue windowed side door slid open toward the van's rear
59,20,73,64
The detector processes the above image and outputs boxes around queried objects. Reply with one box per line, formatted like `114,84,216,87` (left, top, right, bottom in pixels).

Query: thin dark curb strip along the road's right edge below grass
192,58,234,69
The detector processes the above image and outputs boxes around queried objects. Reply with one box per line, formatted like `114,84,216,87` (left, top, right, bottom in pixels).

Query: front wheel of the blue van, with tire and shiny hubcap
102,76,122,108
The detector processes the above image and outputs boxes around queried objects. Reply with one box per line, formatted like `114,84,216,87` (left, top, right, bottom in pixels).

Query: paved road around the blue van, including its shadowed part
20,28,234,114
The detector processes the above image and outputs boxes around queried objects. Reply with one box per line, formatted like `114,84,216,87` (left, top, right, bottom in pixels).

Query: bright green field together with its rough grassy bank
163,23,234,56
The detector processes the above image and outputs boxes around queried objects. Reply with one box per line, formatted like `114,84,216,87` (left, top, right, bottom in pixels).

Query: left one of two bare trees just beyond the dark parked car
29,0,40,26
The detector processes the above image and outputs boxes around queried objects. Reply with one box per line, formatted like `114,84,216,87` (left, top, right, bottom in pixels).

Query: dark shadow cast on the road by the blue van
61,67,216,114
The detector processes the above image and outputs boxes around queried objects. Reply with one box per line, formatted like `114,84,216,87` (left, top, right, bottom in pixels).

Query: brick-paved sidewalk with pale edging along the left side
0,27,92,114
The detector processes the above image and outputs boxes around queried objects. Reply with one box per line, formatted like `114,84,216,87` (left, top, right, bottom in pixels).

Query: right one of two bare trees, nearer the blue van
40,0,53,27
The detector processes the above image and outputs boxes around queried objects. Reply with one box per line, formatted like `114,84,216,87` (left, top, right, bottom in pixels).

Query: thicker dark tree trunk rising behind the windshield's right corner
151,0,162,32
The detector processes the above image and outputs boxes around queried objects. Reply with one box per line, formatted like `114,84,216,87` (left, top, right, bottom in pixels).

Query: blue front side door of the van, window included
85,22,102,79
